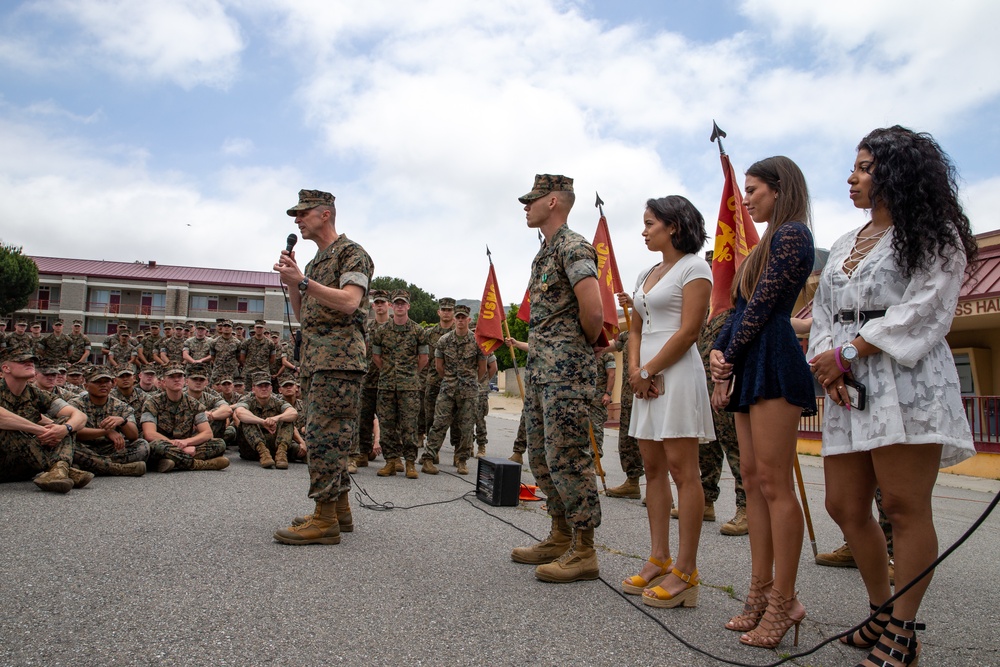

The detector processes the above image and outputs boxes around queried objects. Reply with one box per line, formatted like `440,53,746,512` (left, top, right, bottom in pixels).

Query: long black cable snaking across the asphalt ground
351,464,1000,667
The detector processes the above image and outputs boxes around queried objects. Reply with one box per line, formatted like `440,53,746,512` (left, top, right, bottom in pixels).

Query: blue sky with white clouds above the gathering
0,0,1000,303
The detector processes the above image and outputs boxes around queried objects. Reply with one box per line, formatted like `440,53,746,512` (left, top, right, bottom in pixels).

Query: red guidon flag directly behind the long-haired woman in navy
708,153,760,319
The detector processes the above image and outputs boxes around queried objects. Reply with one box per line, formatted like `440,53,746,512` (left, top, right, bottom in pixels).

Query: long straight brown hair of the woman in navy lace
732,155,811,303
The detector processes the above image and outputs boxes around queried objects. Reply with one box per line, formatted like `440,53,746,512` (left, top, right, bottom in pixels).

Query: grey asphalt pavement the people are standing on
0,402,1000,667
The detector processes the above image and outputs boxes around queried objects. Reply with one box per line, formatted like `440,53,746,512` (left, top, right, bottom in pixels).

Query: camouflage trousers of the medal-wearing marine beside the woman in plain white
524,382,601,529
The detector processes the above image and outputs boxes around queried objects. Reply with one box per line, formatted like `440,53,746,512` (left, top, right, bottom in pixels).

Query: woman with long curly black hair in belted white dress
809,125,976,666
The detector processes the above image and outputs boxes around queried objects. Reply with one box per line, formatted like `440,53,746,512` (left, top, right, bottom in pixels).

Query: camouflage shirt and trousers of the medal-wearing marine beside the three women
524,225,601,530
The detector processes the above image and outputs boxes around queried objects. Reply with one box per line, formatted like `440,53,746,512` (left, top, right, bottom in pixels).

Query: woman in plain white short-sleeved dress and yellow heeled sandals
622,195,715,607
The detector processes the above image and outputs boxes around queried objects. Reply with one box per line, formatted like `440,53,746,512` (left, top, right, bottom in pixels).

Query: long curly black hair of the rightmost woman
858,125,978,278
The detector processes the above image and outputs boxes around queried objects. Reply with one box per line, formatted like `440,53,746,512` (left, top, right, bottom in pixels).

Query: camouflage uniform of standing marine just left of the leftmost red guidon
421,331,486,462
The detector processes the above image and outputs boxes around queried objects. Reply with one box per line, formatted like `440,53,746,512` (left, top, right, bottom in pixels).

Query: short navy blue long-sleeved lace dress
714,222,816,416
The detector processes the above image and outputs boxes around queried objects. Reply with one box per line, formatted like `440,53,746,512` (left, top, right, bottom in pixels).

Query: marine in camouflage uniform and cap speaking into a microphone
274,190,375,545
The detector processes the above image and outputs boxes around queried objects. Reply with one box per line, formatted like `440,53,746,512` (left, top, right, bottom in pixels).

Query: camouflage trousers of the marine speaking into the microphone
302,371,364,503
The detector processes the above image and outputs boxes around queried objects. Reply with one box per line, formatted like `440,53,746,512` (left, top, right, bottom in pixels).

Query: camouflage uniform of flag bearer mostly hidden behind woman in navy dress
698,310,747,507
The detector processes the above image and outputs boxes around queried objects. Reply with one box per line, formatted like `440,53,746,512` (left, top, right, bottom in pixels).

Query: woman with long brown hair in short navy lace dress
711,156,816,648
